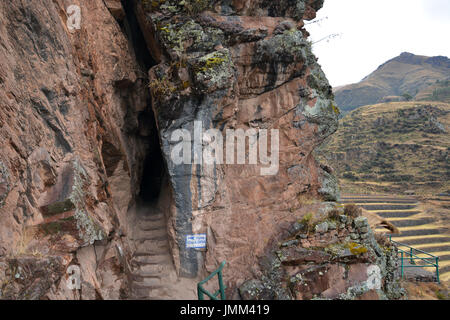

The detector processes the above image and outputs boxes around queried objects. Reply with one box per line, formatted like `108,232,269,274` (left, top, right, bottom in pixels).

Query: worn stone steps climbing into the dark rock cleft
126,208,197,300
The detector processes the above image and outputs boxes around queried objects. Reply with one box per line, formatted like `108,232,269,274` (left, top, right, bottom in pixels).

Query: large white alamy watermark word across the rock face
170,121,280,176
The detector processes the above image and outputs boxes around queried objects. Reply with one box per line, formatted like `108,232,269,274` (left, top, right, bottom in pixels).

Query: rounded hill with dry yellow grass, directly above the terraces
321,102,450,193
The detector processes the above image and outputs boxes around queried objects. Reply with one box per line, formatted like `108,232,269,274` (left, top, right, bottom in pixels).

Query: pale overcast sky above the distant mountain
306,0,450,86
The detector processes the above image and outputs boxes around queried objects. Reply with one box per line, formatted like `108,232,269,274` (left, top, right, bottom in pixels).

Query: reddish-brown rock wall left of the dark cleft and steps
0,0,152,299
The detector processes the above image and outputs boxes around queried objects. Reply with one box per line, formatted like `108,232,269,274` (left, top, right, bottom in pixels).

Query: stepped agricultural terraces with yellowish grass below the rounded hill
341,194,450,281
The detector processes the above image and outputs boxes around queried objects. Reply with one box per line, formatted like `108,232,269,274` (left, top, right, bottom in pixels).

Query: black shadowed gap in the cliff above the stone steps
119,0,167,206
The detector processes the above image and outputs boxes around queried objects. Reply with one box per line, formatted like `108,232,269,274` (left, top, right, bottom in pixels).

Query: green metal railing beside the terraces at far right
389,235,441,283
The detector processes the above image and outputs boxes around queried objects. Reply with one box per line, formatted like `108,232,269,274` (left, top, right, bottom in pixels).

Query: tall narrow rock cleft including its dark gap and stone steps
120,0,197,300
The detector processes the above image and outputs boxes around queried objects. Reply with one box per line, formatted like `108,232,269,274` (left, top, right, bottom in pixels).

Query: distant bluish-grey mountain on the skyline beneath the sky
335,52,450,113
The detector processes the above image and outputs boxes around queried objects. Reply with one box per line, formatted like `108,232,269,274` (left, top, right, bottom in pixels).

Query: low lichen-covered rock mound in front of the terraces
239,208,405,300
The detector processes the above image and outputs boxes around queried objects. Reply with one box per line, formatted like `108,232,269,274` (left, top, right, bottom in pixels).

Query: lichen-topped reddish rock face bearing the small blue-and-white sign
140,0,339,291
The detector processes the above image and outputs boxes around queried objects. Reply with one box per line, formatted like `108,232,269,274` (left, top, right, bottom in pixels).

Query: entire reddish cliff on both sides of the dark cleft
0,0,400,299
